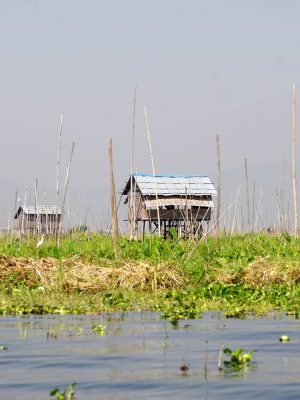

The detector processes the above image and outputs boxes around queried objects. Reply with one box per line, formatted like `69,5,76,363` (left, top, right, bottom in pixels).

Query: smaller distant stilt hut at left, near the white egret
15,204,61,235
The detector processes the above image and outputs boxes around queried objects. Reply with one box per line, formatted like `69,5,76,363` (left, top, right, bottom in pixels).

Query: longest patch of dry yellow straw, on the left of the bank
0,256,187,291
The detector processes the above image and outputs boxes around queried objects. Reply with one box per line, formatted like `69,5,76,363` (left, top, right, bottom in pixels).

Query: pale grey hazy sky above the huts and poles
0,0,300,230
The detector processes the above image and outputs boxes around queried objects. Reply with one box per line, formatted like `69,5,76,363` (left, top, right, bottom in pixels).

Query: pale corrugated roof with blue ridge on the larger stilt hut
123,174,217,196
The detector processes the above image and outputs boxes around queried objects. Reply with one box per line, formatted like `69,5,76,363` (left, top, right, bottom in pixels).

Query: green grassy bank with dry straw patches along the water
0,234,300,319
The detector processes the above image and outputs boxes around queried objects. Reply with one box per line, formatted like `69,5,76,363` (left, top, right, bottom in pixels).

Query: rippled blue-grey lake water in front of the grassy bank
0,312,300,400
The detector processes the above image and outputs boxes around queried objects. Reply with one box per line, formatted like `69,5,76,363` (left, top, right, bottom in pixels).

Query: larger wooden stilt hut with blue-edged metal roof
122,173,217,239
